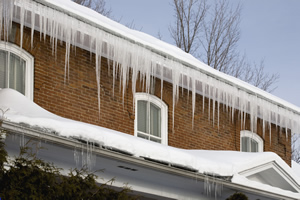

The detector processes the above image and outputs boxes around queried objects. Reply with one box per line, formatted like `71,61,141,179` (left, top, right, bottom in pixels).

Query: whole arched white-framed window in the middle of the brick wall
135,93,168,145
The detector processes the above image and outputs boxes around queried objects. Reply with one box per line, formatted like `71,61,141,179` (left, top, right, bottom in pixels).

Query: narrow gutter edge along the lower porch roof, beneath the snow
0,121,297,200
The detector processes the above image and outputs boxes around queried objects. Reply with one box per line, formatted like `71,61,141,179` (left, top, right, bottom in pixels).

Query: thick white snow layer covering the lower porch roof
0,89,300,198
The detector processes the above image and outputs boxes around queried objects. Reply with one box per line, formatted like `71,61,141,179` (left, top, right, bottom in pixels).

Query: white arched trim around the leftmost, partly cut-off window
0,41,34,100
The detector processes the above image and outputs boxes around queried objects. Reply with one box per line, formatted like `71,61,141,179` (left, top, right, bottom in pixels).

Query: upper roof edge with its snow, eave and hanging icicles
0,0,300,134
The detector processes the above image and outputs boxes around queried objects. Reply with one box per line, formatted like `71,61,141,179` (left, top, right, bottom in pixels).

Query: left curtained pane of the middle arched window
137,101,149,133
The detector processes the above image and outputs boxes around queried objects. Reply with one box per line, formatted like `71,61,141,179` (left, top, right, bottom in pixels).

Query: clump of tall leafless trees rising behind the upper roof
169,0,279,92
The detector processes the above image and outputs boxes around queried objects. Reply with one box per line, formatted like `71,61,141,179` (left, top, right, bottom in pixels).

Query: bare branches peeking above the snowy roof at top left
72,0,111,17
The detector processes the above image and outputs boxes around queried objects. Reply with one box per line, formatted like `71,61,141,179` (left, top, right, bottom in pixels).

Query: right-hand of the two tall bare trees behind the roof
200,0,241,73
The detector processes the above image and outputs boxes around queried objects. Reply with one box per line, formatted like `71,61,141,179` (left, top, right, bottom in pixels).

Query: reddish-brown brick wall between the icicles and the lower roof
4,25,291,164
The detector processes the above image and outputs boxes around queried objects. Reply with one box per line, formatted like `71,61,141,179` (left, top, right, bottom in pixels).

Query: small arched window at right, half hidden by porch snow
241,130,264,152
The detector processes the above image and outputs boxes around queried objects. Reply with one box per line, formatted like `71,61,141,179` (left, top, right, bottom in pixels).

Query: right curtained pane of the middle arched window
150,103,161,137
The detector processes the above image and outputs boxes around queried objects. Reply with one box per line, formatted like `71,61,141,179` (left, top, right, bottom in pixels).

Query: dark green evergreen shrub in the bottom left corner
0,137,137,200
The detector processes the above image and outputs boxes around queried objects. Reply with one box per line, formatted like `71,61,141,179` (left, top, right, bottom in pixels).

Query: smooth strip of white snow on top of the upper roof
39,0,300,113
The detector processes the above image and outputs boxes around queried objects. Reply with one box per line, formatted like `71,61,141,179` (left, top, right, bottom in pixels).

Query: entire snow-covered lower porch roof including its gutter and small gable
0,89,300,198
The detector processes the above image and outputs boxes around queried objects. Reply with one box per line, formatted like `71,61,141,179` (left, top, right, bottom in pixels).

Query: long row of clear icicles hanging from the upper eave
0,0,300,138
